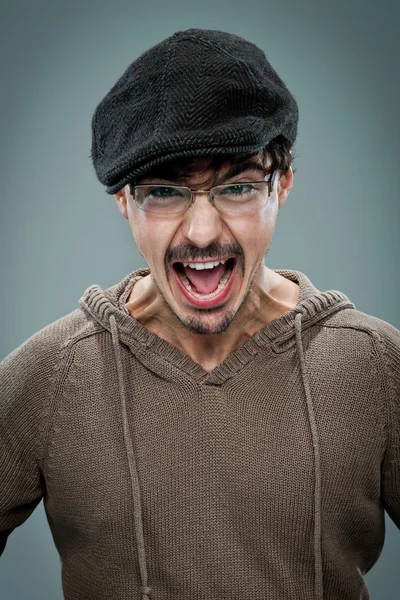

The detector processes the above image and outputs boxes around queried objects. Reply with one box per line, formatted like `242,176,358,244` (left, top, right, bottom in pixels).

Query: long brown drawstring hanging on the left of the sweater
110,315,151,600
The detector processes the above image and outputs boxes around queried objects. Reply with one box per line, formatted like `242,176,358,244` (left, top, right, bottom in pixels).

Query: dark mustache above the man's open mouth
164,242,244,274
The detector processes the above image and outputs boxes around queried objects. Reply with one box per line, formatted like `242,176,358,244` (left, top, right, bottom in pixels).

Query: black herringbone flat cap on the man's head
92,29,298,194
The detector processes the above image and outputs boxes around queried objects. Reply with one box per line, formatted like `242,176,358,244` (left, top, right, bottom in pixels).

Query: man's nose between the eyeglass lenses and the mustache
182,192,223,248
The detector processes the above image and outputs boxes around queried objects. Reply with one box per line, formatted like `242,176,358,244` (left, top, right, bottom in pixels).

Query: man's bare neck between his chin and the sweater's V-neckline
126,266,299,372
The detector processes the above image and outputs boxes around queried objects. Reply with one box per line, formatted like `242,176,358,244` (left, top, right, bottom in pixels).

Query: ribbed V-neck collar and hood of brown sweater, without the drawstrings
81,269,355,385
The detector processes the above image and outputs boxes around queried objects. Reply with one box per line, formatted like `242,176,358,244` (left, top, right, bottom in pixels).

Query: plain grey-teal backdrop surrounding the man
0,0,400,600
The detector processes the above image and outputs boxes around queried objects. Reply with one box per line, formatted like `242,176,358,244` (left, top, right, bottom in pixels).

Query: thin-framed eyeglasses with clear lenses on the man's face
131,171,279,215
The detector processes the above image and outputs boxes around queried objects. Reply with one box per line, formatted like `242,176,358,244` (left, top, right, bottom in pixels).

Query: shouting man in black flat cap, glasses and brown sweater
0,29,400,600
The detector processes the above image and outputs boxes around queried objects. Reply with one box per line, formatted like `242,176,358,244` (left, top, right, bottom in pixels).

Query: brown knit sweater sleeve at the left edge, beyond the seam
0,330,68,555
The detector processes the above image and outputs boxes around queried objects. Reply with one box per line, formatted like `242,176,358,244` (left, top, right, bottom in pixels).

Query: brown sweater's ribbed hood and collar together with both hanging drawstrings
79,269,356,600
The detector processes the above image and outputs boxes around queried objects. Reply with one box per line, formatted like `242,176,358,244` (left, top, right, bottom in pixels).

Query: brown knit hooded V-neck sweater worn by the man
0,270,400,600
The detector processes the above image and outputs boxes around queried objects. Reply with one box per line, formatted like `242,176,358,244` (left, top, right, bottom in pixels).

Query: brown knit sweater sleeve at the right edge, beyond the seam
380,321,400,529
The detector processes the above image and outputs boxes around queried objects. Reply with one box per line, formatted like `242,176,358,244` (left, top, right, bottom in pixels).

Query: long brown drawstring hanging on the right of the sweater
294,313,323,600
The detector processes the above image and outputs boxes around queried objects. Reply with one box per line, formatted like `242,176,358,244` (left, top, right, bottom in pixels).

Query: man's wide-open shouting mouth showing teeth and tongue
173,257,236,301
